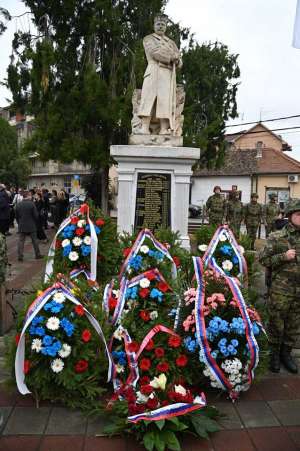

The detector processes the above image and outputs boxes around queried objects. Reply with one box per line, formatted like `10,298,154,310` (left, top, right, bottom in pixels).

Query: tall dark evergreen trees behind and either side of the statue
4,0,237,205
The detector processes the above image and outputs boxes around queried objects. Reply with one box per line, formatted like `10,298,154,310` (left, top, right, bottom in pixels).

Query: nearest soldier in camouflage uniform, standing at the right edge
260,199,300,373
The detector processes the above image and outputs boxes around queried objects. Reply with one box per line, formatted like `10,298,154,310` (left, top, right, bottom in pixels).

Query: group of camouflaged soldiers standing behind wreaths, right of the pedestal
206,186,287,249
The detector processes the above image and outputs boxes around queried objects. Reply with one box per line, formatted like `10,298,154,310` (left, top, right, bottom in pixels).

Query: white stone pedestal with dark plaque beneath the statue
110,145,200,249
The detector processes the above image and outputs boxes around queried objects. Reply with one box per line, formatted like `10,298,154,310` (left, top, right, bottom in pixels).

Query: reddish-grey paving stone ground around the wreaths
0,230,300,451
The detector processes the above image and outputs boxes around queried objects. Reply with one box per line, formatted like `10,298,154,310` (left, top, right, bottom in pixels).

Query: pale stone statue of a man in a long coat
138,15,182,135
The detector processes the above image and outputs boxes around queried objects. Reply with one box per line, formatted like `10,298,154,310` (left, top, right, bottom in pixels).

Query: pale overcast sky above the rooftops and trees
0,0,300,160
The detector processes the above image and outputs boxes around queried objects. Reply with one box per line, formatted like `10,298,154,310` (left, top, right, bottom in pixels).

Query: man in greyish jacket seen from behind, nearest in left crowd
16,191,42,261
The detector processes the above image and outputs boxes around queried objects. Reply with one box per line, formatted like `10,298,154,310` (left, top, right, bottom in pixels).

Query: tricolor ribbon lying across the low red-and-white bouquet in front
128,400,206,423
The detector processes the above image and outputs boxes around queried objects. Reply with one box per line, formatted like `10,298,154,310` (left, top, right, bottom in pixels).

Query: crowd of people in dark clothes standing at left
0,184,69,261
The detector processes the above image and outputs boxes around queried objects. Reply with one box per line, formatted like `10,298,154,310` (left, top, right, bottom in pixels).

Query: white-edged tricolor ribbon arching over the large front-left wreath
15,282,112,395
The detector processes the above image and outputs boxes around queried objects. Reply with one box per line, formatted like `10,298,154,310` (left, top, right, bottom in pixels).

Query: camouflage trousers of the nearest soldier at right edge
268,284,300,351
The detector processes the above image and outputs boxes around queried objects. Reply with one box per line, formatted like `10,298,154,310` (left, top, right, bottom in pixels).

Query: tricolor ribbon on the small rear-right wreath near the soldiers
202,225,248,283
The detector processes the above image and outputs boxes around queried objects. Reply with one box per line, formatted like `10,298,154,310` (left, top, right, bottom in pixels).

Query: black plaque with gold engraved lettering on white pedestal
134,172,171,231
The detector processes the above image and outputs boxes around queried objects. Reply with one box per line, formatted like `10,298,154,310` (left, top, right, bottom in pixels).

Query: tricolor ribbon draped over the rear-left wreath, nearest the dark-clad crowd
44,204,98,282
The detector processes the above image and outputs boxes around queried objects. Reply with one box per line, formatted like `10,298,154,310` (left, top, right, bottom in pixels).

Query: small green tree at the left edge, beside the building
0,118,30,187
